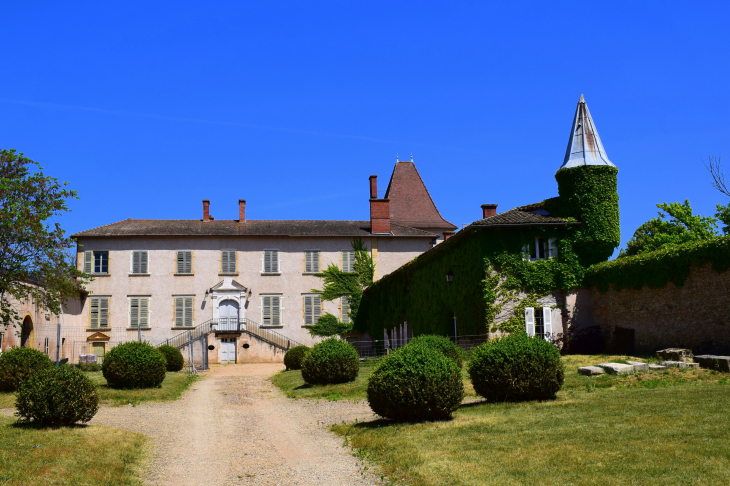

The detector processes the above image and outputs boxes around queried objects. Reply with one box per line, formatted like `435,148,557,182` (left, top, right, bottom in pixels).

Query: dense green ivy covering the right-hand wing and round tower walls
355,166,620,339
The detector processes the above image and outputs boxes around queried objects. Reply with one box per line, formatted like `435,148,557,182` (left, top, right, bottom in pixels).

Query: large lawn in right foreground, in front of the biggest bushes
332,380,730,486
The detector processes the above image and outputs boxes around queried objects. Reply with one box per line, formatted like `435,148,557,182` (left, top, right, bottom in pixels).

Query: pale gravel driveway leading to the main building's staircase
91,364,380,486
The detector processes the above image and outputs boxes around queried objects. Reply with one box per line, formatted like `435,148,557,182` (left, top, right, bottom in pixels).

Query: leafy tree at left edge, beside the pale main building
0,150,89,326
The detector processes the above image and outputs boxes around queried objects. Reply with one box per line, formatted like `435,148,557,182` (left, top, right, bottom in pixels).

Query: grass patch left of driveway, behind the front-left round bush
0,371,198,408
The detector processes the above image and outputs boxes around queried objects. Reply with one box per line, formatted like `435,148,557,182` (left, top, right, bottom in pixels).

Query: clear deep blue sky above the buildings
0,1,730,258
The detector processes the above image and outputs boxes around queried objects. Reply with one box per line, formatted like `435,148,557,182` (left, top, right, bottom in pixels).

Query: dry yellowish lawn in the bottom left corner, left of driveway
0,417,146,486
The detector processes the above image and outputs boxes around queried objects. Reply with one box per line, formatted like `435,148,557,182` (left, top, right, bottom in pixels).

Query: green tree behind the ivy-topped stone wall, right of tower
619,200,718,258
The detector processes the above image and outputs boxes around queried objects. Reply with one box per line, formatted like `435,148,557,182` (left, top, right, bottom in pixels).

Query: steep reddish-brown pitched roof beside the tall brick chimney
385,161,456,230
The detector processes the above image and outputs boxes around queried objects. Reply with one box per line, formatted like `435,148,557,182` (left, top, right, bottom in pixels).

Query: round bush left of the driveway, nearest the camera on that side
15,365,99,426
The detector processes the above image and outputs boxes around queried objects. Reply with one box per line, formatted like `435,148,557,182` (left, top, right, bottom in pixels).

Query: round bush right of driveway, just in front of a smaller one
302,338,360,385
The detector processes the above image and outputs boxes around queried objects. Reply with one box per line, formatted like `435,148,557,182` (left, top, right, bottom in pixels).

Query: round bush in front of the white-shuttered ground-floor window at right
469,333,564,402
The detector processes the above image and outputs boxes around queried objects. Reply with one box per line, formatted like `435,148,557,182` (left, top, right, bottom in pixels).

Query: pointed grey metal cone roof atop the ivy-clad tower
560,95,616,169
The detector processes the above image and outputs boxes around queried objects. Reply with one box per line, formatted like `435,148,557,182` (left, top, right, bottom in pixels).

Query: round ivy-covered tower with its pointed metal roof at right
554,95,621,266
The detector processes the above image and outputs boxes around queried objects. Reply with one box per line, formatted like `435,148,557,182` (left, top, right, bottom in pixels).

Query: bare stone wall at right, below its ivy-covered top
588,264,730,354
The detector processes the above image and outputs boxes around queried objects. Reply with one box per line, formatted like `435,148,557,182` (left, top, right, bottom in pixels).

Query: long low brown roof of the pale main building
71,219,437,238
